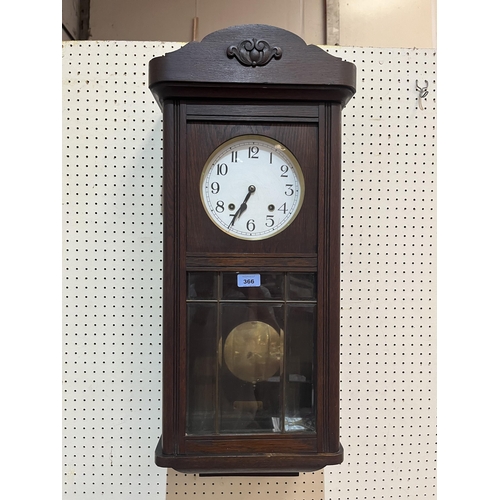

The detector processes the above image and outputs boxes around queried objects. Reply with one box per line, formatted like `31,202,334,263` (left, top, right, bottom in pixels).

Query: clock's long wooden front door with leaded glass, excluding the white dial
164,103,330,468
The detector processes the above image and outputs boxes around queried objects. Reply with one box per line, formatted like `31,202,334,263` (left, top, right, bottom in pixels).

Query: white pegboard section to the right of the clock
325,48,436,500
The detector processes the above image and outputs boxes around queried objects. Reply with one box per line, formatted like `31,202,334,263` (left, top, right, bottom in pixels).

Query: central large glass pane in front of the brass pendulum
219,302,283,434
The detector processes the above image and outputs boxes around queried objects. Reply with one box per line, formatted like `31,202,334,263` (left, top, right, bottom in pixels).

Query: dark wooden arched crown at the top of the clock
149,24,356,106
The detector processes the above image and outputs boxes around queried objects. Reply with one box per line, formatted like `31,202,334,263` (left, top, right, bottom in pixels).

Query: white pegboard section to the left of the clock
63,42,179,498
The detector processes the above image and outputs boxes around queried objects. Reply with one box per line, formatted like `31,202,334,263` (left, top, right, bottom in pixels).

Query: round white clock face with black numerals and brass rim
200,135,305,240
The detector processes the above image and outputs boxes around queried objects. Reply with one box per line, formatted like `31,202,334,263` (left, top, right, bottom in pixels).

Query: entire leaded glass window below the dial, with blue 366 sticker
186,272,317,437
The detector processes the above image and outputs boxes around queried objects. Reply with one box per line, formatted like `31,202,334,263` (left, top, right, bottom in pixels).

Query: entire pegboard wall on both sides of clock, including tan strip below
63,41,436,500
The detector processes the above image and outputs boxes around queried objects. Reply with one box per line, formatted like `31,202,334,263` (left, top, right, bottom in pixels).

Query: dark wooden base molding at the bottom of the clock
155,439,344,476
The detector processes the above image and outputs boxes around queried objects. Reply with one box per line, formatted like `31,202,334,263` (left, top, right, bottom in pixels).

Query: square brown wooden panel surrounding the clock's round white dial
184,122,318,254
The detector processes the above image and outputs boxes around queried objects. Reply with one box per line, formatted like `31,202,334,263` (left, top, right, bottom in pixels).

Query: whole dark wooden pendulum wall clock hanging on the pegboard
149,25,355,475
